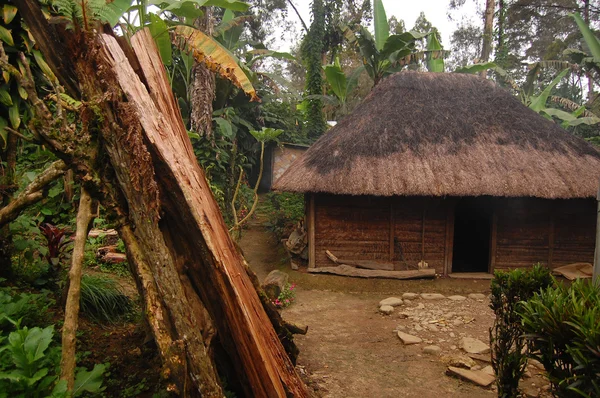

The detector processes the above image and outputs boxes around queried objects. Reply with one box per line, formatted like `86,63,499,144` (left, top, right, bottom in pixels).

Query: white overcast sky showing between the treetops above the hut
279,0,485,50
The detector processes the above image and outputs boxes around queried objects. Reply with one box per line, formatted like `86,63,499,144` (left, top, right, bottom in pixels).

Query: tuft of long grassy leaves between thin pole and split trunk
80,275,132,322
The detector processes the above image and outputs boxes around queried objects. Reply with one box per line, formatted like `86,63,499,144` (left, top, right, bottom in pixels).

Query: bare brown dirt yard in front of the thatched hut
240,223,545,398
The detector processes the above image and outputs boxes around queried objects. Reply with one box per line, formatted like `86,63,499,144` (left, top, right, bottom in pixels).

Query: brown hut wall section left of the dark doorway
315,195,448,273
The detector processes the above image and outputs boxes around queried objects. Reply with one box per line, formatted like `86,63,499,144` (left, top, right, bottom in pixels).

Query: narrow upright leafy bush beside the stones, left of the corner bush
490,264,552,397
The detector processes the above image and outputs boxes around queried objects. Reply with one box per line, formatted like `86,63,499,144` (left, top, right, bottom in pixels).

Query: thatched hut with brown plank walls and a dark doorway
275,72,600,274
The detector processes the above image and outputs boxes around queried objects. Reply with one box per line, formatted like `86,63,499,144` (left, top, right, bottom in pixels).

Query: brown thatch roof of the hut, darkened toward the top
274,72,600,198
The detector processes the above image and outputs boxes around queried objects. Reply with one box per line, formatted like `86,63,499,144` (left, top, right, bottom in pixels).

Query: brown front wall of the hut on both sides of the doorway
309,194,596,274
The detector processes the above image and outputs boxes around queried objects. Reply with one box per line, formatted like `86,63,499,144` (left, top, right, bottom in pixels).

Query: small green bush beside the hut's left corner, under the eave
262,192,304,239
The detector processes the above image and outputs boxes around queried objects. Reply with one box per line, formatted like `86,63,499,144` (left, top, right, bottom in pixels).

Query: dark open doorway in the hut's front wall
452,197,492,272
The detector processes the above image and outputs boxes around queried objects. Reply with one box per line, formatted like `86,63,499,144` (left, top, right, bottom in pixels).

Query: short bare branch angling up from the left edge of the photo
0,160,67,228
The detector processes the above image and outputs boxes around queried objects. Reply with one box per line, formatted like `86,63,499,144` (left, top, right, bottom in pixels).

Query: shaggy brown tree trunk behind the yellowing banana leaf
190,7,216,141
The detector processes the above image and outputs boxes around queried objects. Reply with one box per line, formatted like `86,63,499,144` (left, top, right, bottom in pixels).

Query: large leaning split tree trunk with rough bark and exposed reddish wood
18,0,307,397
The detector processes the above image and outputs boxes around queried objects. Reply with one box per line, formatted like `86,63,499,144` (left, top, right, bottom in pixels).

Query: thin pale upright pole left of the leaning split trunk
60,188,94,393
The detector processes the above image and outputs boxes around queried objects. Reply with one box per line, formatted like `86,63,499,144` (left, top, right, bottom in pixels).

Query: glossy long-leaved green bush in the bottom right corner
520,280,600,397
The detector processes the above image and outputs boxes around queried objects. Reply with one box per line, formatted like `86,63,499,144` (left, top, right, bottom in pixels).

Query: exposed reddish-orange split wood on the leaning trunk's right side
103,30,307,397
